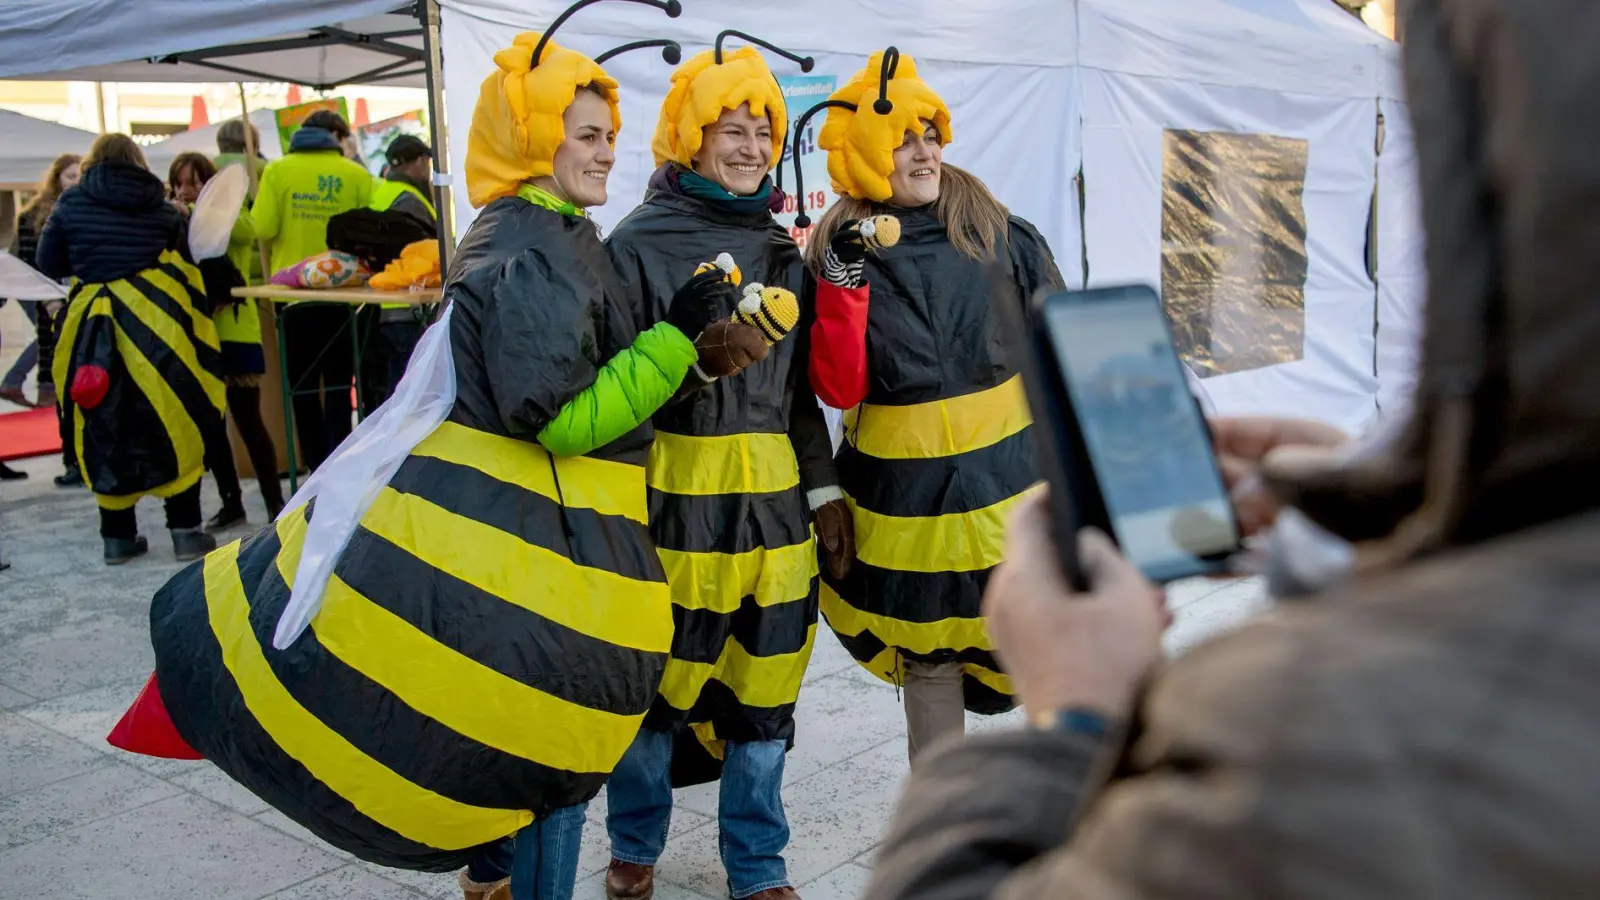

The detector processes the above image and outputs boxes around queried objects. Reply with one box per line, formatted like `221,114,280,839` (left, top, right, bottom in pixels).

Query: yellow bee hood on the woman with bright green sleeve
466,32,622,207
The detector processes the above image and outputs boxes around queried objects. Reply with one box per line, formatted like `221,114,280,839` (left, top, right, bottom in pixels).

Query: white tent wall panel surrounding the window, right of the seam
1078,0,1378,429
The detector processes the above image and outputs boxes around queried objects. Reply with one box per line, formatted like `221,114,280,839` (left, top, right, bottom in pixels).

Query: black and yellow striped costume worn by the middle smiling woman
606,191,835,786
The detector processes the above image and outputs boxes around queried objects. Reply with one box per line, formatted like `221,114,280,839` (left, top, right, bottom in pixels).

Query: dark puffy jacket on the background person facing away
35,162,184,282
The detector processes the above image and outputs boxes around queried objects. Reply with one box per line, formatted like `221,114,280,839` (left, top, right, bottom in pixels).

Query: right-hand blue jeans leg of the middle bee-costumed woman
717,740,790,898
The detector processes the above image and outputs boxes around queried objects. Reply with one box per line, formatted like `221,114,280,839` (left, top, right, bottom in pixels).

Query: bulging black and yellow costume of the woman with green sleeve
152,199,672,871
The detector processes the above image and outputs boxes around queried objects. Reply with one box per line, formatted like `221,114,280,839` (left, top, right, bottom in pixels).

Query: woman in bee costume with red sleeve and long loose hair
795,48,1061,757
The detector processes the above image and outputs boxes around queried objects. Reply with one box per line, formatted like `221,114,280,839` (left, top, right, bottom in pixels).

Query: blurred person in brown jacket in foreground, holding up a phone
869,0,1600,900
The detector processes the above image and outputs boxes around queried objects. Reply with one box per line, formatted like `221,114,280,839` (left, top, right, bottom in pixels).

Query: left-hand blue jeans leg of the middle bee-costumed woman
605,729,672,866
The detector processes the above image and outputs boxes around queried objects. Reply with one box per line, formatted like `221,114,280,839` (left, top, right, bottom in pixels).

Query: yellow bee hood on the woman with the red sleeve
816,51,952,202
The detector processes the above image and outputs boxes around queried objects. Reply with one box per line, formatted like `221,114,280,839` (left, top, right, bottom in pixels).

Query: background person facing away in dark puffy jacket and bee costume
35,135,224,565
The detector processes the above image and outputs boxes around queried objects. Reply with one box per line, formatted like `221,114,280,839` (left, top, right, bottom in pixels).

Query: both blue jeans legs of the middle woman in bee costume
605,729,790,898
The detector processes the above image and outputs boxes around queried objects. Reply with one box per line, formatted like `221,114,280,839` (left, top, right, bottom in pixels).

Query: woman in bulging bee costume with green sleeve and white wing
114,3,768,900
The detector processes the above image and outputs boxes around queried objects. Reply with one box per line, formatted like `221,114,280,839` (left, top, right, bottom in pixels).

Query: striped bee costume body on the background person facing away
53,250,226,509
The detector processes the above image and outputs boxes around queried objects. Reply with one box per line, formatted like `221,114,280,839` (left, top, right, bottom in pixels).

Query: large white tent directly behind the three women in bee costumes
442,0,1422,429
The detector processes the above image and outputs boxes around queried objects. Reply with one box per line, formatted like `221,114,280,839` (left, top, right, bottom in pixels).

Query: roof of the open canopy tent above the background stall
0,0,424,90
